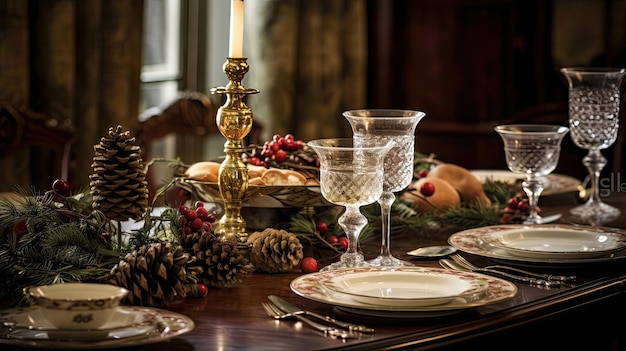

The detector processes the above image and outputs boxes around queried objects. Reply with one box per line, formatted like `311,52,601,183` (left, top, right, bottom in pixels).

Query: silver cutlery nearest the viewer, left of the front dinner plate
261,295,374,340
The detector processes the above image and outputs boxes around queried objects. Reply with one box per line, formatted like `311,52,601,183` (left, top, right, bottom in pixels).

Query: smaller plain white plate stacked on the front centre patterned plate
322,271,487,307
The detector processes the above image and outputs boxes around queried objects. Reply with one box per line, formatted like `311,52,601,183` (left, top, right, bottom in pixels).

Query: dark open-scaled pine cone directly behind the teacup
104,243,196,307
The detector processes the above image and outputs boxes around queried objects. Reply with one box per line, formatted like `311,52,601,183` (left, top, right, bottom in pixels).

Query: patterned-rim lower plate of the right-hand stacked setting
448,224,626,265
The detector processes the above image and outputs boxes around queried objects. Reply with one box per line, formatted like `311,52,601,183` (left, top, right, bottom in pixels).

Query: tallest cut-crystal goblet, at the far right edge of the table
561,67,626,223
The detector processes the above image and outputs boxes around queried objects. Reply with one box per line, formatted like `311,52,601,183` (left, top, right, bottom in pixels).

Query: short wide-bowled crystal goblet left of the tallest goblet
495,124,569,224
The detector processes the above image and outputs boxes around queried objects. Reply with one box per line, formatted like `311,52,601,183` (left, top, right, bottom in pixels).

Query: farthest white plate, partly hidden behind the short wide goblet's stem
470,169,581,196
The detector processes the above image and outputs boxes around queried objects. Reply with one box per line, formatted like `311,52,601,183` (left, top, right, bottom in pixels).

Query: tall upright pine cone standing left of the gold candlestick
89,125,148,221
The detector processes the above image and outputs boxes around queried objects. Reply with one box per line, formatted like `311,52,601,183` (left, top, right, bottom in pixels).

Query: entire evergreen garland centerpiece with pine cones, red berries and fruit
0,126,528,307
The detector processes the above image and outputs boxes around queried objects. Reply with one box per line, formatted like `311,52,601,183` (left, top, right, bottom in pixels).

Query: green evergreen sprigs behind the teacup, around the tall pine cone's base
0,191,178,307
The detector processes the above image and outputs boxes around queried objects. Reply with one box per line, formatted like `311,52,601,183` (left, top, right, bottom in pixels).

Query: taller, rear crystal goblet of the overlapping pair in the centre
343,109,426,266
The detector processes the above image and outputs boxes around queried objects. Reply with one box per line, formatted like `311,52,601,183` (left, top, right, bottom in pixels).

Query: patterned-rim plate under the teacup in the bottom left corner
0,306,194,350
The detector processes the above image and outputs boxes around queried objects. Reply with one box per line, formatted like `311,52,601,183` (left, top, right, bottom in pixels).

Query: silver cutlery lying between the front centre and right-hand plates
439,254,576,289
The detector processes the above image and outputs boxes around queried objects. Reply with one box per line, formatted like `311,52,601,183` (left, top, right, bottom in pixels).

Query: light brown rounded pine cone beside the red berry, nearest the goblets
248,228,304,273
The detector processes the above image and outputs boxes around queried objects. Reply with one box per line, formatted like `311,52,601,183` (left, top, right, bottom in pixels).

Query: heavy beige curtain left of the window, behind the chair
0,0,143,190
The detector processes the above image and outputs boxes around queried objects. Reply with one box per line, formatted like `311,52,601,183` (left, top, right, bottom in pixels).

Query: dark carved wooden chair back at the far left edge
0,103,75,190
